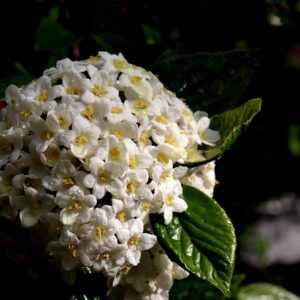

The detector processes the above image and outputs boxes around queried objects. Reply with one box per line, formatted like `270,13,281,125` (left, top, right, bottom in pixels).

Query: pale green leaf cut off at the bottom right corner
236,283,300,300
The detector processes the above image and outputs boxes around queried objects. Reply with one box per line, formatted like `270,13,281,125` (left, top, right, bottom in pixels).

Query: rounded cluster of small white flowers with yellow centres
0,52,219,299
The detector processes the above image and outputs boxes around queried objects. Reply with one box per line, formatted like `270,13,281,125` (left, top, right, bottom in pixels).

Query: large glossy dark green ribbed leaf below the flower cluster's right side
152,185,236,296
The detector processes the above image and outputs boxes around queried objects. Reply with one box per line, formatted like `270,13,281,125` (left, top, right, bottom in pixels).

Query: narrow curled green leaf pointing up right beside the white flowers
179,99,261,167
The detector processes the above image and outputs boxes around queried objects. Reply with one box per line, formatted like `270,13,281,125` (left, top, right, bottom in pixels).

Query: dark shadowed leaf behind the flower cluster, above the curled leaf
152,50,261,115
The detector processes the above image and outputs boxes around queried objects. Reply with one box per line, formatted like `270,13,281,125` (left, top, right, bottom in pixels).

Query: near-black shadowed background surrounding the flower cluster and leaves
0,0,300,299
